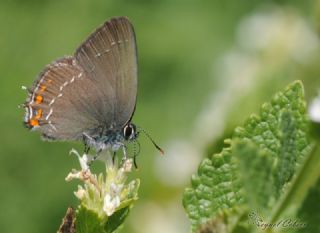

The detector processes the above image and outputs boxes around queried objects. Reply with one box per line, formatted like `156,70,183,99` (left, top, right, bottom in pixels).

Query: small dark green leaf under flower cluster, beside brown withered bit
76,206,105,233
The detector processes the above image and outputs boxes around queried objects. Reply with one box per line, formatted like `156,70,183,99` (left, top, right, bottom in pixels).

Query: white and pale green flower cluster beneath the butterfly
66,149,139,218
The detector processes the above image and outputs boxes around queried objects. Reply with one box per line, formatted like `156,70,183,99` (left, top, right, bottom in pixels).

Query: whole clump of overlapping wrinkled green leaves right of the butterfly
183,81,311,232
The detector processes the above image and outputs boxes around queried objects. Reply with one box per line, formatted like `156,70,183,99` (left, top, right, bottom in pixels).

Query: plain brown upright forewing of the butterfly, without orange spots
75,17,138,128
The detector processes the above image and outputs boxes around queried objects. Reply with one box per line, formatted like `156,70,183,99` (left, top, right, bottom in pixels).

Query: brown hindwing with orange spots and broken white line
24,57,109,140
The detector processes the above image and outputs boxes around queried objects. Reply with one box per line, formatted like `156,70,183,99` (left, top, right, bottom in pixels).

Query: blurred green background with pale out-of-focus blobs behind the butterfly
0,0,320,233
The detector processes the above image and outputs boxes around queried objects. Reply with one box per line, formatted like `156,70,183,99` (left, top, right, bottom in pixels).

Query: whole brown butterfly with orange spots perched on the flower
23,17,163,166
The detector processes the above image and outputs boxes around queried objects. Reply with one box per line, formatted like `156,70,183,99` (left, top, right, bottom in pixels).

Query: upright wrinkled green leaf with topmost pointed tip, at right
234,81,311,204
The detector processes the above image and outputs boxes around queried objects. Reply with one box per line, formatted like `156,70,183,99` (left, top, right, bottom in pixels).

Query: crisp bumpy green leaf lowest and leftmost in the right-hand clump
183,149,243,231
